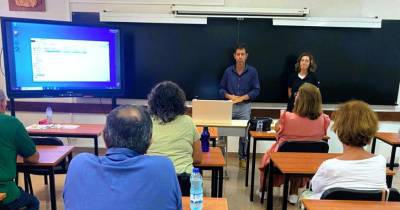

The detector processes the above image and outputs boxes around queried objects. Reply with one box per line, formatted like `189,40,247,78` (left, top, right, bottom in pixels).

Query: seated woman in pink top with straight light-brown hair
259,83,330,203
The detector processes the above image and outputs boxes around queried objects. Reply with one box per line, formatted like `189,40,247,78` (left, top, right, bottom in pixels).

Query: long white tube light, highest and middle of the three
171,6,310,17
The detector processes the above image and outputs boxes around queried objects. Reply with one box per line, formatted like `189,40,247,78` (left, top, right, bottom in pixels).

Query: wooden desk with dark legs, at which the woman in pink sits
246,131,329,201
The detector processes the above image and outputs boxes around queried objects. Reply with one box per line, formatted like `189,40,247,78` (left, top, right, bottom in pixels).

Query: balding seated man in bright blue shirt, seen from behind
64,105,182,210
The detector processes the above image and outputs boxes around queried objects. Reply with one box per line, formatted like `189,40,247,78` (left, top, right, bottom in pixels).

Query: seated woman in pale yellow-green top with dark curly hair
147,81,202,196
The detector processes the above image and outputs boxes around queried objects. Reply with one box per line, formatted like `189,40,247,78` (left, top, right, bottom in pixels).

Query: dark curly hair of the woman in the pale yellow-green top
147,81,186,123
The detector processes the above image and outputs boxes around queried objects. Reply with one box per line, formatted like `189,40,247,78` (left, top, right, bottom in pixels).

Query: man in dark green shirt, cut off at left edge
0,89,39,210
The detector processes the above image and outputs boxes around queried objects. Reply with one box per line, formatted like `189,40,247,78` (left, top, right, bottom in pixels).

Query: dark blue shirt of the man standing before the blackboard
219,64,260,100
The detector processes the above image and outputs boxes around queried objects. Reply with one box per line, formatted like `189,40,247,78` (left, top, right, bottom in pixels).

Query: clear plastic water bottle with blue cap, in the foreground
190,168,203,210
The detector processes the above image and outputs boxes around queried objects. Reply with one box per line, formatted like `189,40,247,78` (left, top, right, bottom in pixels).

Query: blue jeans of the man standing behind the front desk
232,103,251,160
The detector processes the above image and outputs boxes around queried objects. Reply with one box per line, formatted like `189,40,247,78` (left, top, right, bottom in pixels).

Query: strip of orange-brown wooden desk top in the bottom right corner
303,199,400,210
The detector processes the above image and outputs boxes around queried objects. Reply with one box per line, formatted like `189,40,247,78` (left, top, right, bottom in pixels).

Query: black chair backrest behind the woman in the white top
321,187,386,201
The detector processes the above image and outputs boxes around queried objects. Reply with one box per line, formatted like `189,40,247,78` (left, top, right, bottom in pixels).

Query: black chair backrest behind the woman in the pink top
278,140,329,153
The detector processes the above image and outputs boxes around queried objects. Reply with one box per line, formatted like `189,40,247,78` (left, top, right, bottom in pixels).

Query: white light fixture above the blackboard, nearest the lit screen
100,11,207,24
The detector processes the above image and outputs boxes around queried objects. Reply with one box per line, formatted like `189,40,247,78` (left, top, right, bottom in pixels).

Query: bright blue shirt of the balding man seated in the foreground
64,148,182,210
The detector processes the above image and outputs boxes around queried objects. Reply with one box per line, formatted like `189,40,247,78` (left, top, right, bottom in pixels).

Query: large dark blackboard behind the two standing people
73,13,400,105
